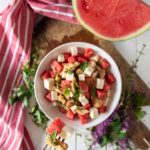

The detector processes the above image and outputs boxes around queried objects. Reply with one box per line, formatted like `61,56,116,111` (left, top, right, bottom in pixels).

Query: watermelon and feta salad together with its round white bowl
34,42,121,129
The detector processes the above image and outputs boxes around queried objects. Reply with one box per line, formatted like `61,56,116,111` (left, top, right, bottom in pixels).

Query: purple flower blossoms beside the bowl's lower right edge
91,105,130,150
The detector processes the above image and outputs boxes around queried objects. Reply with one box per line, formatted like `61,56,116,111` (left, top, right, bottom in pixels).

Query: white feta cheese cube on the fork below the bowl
60,126,74,140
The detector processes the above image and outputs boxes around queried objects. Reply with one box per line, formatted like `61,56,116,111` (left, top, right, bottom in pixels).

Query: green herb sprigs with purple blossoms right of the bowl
91,45,149,149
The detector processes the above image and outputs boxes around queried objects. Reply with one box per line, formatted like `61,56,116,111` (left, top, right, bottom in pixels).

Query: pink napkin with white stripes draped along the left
0,0,76,150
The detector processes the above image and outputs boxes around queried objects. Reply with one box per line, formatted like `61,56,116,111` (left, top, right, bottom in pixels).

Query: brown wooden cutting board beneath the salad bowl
33,18,150,149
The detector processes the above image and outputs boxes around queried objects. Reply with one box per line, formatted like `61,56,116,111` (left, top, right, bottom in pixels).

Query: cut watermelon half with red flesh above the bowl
72,0,150,41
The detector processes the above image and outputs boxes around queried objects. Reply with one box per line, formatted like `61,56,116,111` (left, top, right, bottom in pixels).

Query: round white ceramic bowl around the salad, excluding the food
34,42,122,129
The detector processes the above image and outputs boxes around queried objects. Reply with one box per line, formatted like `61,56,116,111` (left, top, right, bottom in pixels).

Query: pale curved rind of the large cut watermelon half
72,0,150,41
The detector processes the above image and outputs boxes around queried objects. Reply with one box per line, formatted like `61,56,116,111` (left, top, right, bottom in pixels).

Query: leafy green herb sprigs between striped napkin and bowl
9,40,48,127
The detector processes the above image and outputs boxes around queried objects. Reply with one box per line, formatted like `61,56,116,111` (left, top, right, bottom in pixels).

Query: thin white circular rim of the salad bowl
34,42,122,129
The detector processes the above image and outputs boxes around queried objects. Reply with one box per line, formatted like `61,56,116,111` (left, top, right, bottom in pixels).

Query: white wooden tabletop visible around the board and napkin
0,0,150,150
